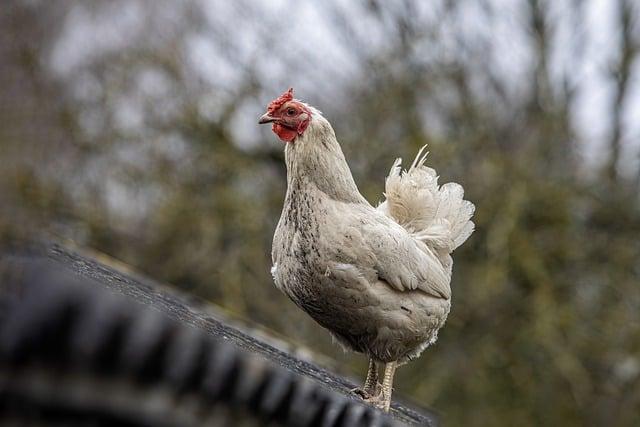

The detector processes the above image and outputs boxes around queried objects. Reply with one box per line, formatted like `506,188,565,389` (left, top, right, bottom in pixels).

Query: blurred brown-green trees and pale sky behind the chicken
0,0,640,426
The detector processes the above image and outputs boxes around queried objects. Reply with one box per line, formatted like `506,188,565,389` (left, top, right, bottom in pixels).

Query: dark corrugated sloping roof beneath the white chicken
0,244,436,426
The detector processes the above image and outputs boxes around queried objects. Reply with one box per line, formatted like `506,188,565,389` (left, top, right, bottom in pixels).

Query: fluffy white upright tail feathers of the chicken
378,146,475,254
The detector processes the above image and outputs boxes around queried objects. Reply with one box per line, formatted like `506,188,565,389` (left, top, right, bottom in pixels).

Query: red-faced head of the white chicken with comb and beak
258,88,311,142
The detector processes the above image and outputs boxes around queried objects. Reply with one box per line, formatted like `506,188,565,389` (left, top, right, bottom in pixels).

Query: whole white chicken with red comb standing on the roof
259,89,474,411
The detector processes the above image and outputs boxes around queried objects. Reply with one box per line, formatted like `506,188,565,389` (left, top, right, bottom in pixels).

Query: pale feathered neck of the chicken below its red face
285,117,368,204
